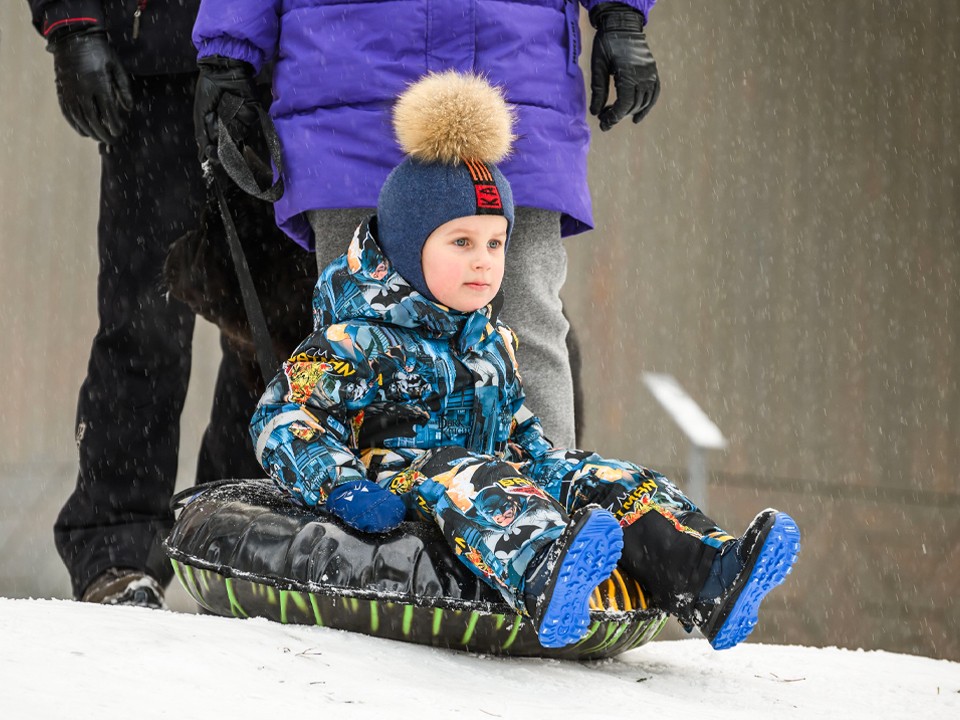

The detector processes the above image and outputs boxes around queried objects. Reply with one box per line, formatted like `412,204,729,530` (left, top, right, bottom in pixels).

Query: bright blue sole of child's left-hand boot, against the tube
537,511,623,648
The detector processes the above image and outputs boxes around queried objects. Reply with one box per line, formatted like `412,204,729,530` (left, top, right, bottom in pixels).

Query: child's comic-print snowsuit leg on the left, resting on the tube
381,447,568,613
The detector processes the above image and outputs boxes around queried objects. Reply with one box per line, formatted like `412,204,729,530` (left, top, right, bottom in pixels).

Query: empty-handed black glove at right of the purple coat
590,2,660,131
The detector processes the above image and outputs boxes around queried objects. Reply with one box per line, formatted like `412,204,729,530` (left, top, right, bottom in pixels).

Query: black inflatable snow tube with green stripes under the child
164,480,666,660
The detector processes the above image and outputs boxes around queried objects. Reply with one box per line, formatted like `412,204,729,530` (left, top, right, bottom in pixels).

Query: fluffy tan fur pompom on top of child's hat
393,70,515,165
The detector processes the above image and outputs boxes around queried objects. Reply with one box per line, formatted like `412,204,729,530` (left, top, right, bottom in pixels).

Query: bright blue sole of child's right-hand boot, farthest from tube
708,513,800,650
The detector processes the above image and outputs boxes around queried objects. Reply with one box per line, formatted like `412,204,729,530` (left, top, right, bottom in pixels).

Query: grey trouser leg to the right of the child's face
500,207,576,447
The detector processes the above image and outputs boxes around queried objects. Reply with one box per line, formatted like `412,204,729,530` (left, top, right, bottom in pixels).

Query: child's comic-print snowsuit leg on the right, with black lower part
521,450,732,618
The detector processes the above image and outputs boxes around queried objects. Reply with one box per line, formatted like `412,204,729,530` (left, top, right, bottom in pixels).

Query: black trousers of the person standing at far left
54,74,262,597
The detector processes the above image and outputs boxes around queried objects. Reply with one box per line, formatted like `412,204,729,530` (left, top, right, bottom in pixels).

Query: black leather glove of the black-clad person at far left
47,28,133,145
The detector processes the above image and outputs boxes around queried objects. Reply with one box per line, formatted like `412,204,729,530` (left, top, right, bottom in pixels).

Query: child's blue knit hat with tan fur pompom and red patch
377,70,514,301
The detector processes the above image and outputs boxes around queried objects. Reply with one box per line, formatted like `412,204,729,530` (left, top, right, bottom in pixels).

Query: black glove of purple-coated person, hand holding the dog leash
193,55,259,162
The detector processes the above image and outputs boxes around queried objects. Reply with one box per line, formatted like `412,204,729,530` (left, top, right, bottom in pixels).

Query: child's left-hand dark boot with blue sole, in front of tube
523,505,623,648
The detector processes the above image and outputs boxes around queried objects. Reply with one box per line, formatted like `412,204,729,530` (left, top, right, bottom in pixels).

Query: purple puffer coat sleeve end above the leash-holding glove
193,0,280,72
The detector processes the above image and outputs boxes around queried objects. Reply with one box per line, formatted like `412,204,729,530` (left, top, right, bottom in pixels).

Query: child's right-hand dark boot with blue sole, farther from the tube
695,508,800,650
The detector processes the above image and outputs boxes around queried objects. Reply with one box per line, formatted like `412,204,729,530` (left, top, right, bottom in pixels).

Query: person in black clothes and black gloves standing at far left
28,0,270,606
